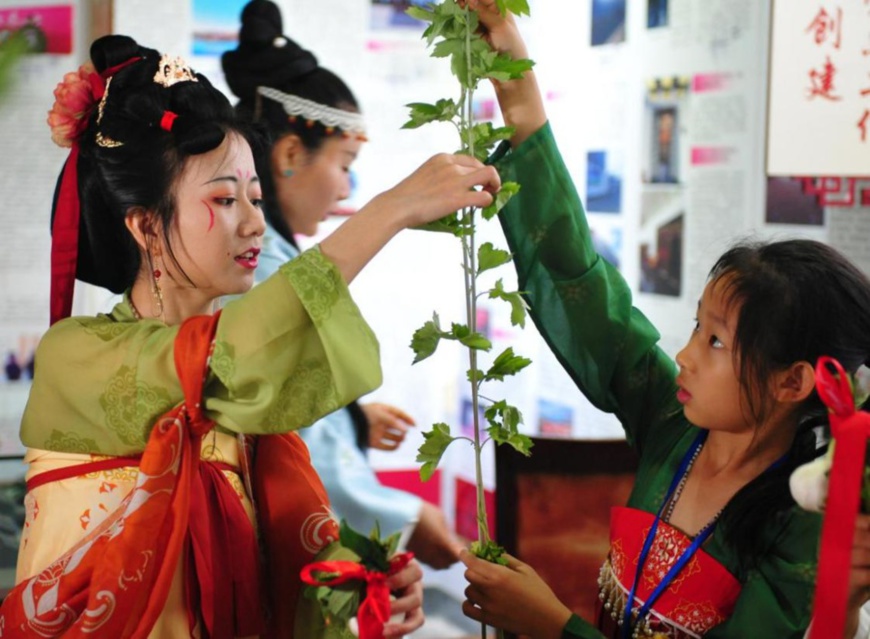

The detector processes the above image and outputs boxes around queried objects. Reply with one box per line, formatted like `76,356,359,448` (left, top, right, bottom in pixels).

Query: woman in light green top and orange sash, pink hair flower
0,35,499,639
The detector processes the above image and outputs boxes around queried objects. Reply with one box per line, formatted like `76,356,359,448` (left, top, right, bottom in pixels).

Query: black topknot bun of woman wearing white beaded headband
221,0,319,100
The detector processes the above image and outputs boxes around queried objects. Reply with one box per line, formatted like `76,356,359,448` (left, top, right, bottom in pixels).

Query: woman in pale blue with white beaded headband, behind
222,0,460,568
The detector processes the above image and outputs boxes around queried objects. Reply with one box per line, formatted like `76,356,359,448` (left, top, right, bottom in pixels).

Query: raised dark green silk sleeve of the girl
496,124,681,456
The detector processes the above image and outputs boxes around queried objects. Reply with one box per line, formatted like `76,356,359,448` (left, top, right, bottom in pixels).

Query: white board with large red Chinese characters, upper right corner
767,0,870,176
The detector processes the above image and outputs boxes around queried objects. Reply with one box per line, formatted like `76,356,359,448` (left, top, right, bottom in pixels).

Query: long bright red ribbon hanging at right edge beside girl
810,357,870,639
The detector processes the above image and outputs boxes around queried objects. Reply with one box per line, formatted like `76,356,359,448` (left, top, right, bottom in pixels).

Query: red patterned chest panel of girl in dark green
599,506,741,637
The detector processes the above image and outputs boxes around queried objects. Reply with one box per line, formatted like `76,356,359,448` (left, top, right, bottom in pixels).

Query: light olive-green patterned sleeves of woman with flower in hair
21,248,381,455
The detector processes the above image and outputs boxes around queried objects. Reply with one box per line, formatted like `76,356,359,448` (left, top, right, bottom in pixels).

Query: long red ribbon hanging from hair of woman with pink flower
50,56,141,324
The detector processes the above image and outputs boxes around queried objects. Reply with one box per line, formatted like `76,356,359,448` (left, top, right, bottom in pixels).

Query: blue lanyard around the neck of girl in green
622,430,716,639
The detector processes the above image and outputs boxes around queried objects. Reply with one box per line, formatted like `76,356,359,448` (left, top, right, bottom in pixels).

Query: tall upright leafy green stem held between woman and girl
403,0,533,561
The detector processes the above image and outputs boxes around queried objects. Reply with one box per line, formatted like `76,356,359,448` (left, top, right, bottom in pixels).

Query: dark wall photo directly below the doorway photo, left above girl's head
639,213,685,297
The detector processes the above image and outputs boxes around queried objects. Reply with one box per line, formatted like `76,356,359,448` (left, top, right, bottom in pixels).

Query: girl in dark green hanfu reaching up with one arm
461,0,870,639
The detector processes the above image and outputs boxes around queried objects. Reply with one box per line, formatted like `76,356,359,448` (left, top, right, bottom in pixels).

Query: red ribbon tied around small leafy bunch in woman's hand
300,552,414,639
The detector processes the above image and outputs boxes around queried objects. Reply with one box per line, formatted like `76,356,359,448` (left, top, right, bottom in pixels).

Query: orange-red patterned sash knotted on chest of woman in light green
0,314,259,638
